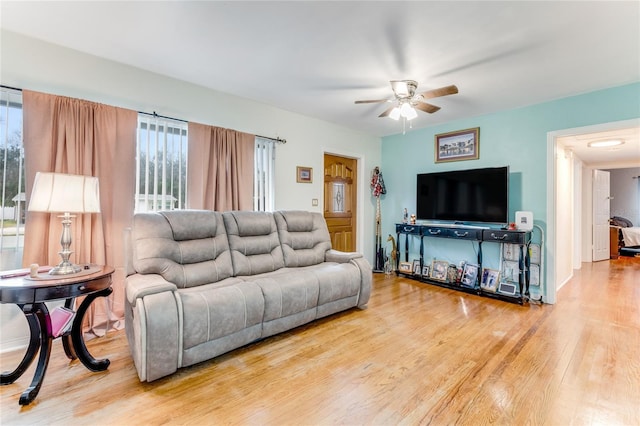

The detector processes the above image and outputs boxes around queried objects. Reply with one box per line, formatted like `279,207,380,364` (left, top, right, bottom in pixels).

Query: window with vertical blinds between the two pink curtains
135,114,187,212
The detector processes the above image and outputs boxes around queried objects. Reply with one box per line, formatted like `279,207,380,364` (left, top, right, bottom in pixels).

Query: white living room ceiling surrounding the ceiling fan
0,0,640,166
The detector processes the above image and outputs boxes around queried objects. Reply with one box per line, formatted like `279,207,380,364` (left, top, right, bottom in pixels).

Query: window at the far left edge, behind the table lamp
0,88,26,270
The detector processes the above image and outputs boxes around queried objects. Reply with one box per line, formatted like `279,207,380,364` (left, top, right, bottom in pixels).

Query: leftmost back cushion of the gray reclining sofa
132,210,233,288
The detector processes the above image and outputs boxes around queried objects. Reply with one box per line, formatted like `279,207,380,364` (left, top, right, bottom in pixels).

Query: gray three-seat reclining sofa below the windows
125,210,372,382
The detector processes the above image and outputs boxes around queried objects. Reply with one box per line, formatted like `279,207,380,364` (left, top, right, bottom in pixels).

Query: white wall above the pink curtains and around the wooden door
0,31,380,351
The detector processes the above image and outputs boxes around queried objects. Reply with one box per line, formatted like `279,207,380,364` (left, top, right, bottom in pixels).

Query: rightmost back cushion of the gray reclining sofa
274,211,331,267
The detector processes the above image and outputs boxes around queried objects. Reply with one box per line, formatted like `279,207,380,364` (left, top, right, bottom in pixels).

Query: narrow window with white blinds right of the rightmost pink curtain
253,136,276,212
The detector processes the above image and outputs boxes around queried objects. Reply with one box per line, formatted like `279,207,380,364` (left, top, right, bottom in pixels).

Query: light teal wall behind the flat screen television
381,82,640,286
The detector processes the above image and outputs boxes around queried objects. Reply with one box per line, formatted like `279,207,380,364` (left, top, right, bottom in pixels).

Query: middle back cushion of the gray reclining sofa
222,211,284,276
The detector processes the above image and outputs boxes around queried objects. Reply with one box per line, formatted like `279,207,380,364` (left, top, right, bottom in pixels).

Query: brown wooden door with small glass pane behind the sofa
324,154,358,251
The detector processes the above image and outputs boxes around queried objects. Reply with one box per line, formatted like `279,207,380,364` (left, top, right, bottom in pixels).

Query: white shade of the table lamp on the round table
29,172,100,213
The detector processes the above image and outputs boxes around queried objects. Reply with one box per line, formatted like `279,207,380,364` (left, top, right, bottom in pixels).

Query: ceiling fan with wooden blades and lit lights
355,80,458,120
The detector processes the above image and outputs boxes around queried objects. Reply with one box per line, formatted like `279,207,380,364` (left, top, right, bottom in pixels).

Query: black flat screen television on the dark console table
416,166,509,224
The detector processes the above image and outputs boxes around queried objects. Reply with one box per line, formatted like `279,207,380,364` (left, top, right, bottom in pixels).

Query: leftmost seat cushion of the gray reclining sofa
177,278,264,350
